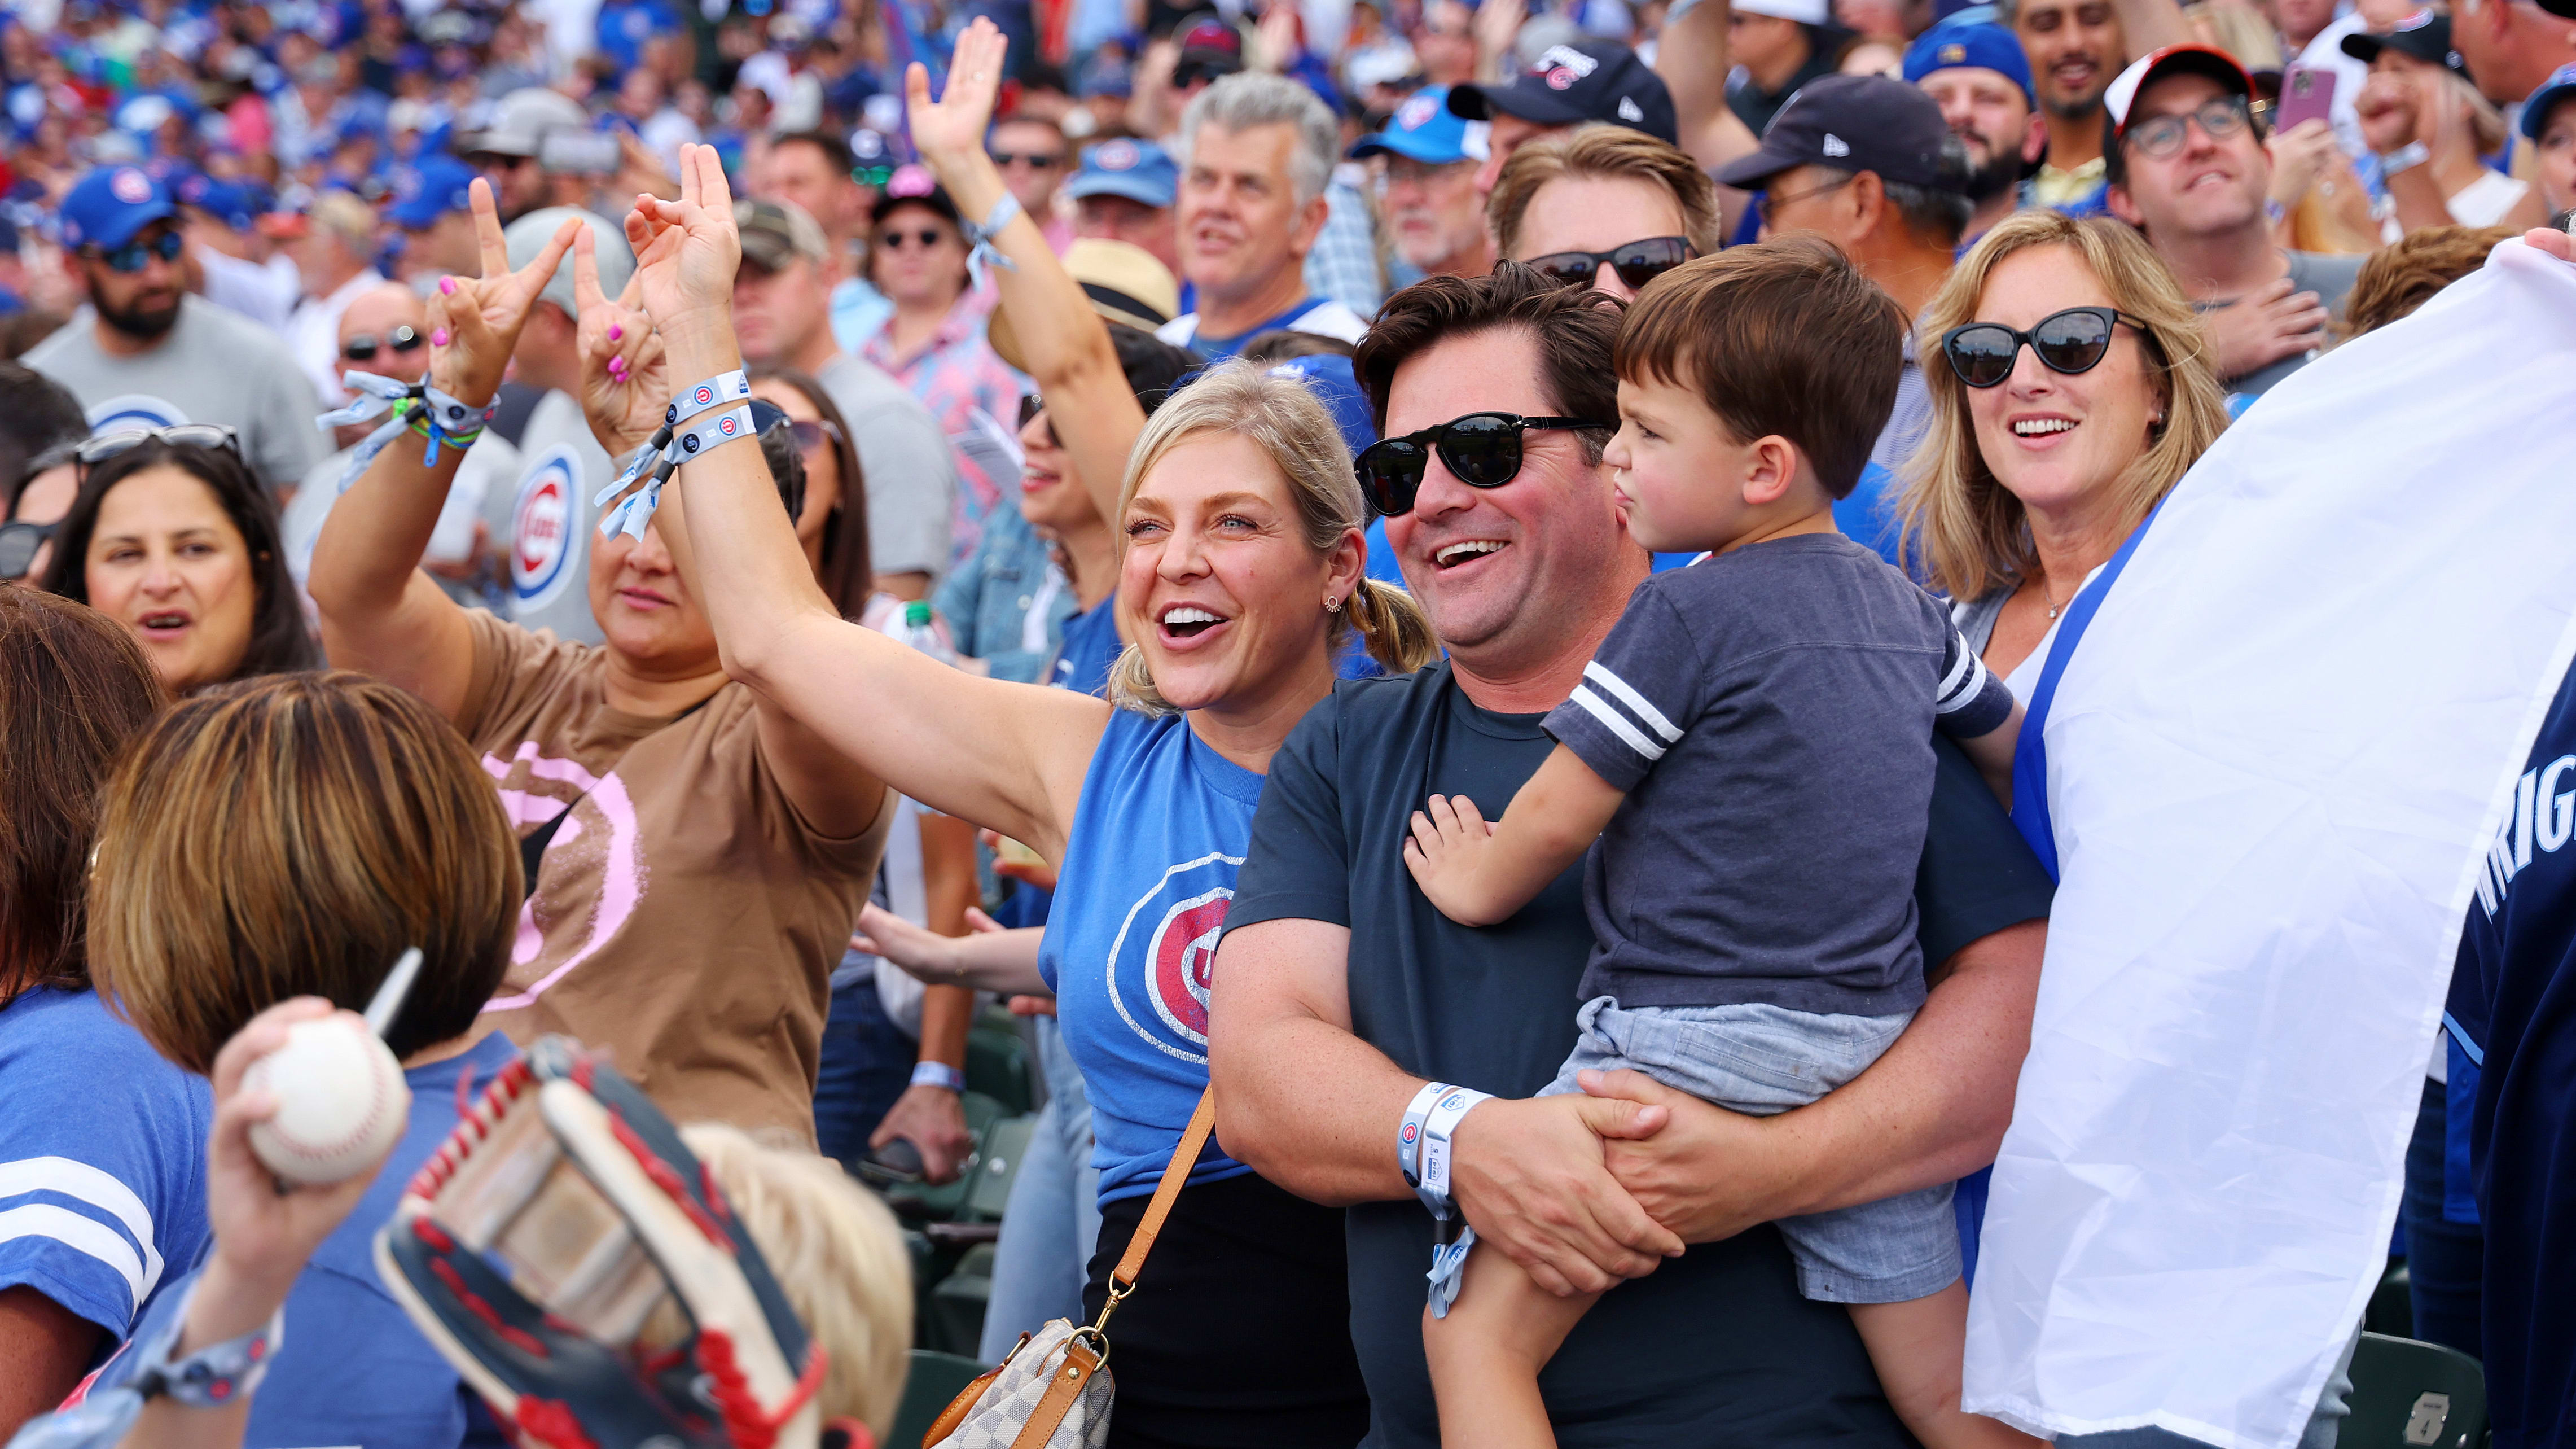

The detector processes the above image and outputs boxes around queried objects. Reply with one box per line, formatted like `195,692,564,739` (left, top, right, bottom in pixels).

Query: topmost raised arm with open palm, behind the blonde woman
904,21,1144,528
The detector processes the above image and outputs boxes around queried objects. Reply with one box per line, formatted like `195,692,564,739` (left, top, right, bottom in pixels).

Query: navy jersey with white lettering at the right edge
2450,657,2576,1449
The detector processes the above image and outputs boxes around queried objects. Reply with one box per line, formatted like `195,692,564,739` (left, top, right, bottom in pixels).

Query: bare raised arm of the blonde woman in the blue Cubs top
626,147,1108,859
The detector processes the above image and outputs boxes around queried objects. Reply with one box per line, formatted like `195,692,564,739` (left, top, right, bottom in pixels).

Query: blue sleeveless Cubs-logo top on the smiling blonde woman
1038,709,1262,1202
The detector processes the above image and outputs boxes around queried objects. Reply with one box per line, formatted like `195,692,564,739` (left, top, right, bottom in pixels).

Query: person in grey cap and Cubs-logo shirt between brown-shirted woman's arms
484,206,637,645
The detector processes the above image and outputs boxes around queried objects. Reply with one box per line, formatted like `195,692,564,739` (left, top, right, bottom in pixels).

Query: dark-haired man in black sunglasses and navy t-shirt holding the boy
1208,263,2048,1449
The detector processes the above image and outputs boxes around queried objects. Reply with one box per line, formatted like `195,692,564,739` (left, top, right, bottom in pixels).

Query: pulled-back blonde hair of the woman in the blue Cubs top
1108,361,1440,714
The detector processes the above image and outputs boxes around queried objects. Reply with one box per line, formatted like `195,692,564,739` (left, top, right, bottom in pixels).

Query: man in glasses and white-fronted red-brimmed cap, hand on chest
2102,44,2365,397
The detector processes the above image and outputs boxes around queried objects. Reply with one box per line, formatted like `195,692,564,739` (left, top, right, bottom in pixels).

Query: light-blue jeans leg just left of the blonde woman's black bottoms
976,1016,1100,1364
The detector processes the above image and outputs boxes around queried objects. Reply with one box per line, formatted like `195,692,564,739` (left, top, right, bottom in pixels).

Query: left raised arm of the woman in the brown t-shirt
306,181,582,719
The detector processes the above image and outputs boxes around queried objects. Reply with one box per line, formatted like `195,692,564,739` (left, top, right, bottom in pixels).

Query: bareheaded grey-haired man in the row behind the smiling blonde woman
1157,72,1368,358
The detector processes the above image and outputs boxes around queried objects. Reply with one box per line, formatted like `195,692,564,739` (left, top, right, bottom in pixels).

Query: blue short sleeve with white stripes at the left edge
0,987,214,1343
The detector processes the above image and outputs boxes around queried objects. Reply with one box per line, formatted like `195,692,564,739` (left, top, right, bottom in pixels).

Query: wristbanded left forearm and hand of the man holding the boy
1208,921,1679,1294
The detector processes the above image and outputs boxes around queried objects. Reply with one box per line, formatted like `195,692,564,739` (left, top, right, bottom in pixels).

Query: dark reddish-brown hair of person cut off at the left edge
0,583,165,1005
